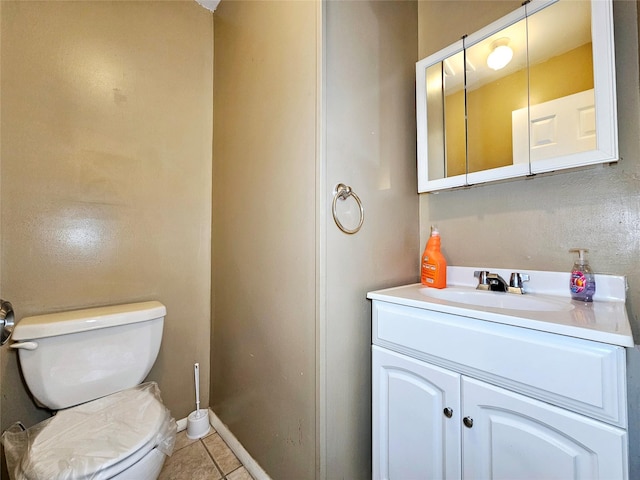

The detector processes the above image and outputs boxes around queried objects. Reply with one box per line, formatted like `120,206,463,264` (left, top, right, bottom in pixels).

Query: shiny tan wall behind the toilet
0,1,213,436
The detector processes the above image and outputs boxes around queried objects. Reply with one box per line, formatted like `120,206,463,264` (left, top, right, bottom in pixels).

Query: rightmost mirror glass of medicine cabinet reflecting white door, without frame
513,2,596,168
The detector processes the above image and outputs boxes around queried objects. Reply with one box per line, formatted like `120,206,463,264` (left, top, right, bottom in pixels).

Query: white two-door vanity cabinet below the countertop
370,296,628,480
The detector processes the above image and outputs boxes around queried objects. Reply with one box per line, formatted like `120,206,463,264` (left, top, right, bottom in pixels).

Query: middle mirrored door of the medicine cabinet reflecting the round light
465,14,529,184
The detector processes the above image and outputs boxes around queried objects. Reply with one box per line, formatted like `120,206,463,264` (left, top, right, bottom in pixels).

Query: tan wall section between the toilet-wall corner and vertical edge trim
211,1,317,479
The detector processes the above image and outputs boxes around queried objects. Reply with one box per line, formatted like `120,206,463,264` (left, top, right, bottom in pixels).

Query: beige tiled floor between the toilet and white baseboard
158,427,253,480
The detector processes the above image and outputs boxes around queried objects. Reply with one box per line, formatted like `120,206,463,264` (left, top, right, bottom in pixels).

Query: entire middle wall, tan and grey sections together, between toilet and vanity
211,1,419,480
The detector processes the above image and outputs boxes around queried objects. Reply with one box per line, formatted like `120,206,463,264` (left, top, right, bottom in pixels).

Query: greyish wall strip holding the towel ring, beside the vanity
317,0,419,480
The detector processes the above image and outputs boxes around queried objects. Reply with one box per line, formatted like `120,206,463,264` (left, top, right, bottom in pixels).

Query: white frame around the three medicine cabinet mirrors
416,0,619,193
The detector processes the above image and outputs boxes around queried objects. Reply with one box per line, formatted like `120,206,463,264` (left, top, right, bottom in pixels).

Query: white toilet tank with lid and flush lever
11,301,166,410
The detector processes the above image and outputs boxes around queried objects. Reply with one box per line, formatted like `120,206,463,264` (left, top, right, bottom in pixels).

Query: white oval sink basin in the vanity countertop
420,287,574,312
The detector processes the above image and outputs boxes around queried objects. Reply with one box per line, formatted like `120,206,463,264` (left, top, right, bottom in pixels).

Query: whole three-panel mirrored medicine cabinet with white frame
416,0,618,192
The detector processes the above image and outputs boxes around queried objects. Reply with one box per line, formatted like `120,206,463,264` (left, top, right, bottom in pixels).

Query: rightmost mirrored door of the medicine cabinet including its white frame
514,0,617,173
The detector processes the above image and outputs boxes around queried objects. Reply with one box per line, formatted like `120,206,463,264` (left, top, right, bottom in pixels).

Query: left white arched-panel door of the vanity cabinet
372,346,461,480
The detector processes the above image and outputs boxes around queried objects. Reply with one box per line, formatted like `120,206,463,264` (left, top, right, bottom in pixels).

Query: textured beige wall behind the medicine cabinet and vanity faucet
416,0,640,472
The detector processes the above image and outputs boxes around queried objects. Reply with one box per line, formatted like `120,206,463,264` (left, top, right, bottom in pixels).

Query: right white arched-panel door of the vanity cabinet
462,377,627,480
